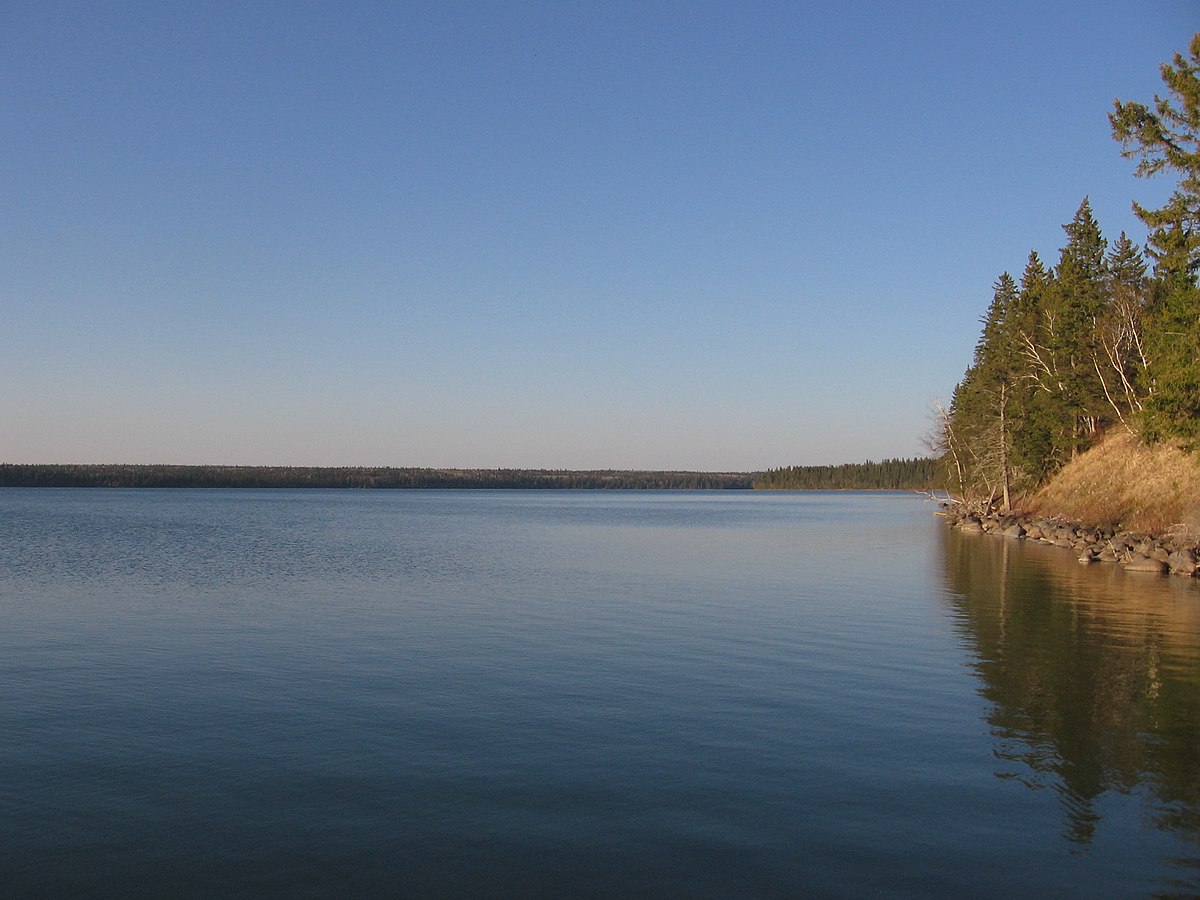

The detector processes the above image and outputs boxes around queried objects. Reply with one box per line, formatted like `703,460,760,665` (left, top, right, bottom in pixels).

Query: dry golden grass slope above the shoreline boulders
1026,431,1200,534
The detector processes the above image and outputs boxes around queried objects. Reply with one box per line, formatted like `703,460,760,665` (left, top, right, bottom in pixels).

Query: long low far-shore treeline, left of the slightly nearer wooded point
0,463,755,491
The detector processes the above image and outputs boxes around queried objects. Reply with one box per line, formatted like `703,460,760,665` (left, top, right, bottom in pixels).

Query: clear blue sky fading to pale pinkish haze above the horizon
0,0,1200,470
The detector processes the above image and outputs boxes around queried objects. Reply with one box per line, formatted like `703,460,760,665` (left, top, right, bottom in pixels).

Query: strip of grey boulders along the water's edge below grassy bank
938,503,1200,577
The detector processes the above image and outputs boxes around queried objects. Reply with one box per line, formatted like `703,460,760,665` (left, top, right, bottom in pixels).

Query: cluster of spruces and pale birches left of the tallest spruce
943,198,1150,506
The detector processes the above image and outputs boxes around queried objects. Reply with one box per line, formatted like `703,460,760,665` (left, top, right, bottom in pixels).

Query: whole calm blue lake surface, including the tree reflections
0,490,1200,898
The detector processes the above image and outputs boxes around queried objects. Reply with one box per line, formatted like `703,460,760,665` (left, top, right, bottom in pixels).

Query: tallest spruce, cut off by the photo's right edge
1109,34,1200,445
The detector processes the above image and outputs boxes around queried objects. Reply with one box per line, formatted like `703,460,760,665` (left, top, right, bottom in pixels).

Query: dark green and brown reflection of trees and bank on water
942,528,1200,894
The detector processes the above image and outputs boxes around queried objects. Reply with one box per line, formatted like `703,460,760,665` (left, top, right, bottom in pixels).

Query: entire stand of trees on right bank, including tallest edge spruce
931,34,1200,505
